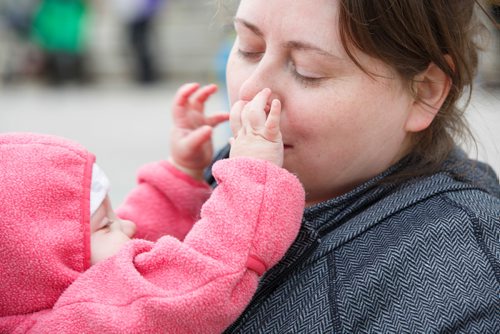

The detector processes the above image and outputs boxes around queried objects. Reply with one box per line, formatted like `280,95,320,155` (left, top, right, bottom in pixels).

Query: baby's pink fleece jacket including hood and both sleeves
0,134,304,333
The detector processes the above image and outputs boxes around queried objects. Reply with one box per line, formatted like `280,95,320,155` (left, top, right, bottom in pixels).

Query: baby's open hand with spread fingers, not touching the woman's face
170,83,229,179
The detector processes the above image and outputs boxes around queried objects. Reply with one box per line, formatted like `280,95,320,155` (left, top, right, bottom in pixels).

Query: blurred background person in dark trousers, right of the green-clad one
113,0,164,84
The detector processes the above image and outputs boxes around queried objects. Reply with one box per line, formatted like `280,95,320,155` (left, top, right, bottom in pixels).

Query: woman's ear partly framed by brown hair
405,56,451,132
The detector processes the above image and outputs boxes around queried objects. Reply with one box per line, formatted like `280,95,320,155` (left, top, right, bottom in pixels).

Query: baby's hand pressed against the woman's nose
230,88,283,167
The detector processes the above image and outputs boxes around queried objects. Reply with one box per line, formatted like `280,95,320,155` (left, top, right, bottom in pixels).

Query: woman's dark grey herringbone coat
204,147,500,334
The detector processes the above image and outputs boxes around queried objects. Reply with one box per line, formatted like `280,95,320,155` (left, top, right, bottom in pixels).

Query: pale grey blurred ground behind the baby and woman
0,83,500,206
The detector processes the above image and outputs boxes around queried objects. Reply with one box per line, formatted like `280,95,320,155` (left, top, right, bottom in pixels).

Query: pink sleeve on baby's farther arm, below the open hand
116,161,211,241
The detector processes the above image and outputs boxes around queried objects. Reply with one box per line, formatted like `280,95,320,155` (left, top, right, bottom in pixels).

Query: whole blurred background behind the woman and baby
0,0,500,206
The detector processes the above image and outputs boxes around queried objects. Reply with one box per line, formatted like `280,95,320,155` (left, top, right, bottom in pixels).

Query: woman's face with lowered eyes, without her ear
227,0,413,204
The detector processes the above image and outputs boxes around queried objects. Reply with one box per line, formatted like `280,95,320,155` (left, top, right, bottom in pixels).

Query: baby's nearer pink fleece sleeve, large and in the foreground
21,158,304,333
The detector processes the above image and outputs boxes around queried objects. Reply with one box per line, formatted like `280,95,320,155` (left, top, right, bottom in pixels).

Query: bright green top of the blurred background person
33,0,87,53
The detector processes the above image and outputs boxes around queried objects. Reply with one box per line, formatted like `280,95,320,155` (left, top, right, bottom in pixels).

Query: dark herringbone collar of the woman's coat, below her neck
303,148,500,237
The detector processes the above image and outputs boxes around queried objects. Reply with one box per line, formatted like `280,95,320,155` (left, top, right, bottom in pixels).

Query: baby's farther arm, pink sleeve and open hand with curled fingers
117,83,229,241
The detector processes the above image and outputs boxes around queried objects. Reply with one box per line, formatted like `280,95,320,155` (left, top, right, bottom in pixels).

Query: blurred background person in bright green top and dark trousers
32,0,88,85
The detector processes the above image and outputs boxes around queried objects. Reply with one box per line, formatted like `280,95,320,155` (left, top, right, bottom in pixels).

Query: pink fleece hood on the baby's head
0,133,95,317
